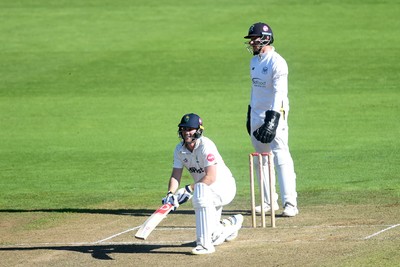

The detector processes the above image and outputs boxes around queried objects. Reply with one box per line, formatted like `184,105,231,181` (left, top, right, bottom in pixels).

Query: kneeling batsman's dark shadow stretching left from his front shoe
0,242,195,260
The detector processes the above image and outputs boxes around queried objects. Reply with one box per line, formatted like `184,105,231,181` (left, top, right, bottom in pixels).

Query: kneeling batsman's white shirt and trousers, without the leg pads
173,136,236,202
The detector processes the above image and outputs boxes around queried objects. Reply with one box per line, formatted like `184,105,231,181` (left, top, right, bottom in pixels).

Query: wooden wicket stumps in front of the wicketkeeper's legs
249,152,275,228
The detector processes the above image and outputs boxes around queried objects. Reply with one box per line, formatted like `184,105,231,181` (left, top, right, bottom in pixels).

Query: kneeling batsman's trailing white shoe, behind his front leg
213,214,243,246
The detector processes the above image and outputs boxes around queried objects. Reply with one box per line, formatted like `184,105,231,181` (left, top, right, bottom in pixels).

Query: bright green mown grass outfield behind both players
0,0,400,210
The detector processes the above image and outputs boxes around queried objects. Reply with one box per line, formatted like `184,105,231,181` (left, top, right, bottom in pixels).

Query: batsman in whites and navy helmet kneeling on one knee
163,113,243,254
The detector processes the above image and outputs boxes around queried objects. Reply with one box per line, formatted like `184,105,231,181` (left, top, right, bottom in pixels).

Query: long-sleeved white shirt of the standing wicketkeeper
250,47,289,118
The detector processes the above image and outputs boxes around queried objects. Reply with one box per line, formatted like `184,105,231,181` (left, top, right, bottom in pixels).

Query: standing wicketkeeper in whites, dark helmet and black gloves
244,22,299,217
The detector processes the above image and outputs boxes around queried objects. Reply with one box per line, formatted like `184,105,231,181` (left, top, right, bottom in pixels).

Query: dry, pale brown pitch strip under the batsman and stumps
0,206,400,266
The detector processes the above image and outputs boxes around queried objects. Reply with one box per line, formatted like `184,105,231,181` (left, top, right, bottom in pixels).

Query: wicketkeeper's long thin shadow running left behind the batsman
0,208,250,217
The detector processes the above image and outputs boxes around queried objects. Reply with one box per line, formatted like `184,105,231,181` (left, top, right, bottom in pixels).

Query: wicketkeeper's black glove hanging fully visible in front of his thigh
253,110,281,144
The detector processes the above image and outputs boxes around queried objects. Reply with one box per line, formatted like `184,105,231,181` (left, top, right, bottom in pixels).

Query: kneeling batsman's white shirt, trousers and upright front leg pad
173,136,236,248
